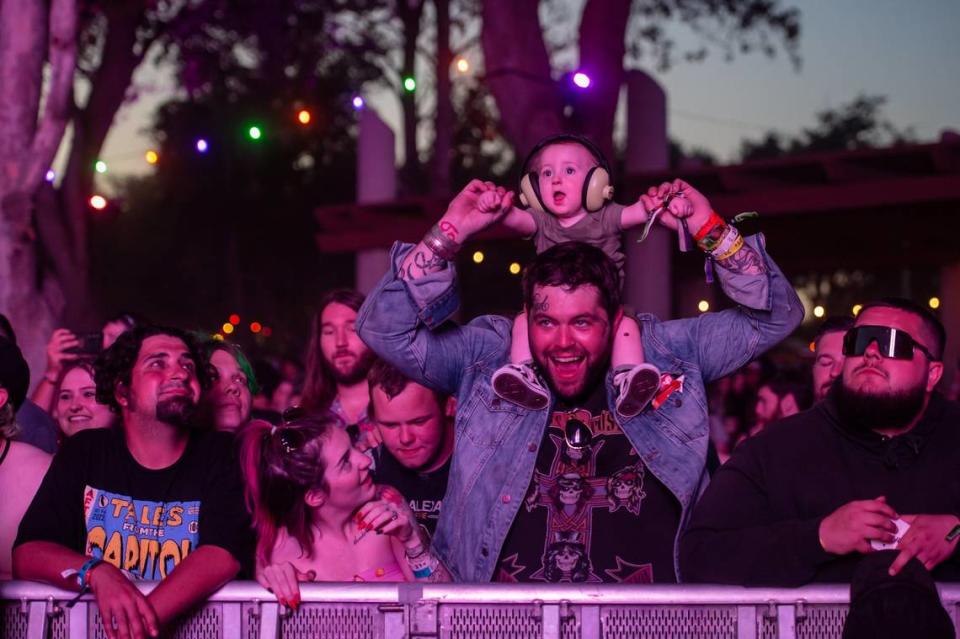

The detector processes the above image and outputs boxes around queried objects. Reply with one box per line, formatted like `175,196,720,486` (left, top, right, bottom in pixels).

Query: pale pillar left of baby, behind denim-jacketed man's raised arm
354,107,397,294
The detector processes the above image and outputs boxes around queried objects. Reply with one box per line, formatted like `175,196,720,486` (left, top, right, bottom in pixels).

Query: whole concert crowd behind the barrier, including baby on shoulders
0,135,960,639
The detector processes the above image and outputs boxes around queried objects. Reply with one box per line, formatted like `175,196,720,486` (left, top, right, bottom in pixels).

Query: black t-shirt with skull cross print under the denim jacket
494,384,680,583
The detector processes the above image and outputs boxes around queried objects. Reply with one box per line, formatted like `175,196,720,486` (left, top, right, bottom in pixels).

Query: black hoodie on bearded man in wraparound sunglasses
680,393,960,586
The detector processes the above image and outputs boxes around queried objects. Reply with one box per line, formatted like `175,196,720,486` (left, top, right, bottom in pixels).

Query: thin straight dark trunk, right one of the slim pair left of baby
430,0,453,196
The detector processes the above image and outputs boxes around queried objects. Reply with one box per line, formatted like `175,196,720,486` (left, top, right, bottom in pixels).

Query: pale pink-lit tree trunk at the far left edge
0,0,77,382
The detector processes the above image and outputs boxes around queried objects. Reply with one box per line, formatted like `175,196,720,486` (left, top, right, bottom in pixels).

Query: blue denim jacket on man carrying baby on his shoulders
357,236,803,582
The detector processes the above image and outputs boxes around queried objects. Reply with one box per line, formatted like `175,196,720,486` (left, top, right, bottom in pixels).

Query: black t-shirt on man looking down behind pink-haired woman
373,445,450,537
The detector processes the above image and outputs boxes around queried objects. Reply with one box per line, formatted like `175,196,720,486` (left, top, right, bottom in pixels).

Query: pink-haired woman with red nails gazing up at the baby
240,411,449,608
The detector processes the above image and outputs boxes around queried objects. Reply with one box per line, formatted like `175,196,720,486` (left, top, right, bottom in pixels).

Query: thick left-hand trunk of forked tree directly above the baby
480,0,565,158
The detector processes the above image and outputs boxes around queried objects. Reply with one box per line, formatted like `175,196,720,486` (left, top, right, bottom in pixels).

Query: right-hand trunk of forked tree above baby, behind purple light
577,0,630,161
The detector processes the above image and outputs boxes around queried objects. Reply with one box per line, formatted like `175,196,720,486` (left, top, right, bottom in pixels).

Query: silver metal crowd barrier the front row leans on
0,581,960,639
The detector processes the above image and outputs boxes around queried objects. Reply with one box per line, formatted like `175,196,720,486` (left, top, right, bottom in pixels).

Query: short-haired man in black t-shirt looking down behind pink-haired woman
367,361,455,535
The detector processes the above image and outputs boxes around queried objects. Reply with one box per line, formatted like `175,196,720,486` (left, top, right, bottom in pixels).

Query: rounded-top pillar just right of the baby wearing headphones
624,71,677,319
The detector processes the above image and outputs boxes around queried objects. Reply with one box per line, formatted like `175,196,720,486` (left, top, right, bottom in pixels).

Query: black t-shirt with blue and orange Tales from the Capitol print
16,428,253,580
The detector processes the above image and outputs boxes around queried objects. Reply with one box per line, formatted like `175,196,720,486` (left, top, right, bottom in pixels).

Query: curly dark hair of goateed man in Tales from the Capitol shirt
93,325,210,413
